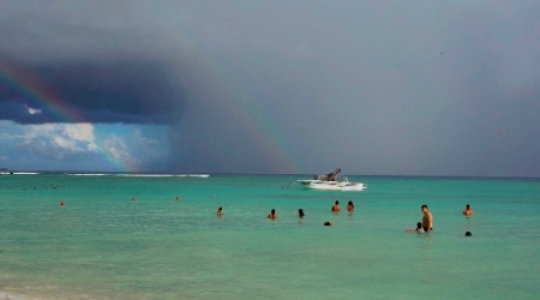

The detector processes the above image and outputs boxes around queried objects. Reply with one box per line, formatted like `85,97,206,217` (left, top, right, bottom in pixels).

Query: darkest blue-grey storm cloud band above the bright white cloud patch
0,60,185,124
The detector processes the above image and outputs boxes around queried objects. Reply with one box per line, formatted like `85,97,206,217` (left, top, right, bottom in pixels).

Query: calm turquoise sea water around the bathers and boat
0,174,540,299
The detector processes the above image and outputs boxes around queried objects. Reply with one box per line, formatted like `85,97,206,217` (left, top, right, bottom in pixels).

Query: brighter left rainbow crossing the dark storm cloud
0,61,130,172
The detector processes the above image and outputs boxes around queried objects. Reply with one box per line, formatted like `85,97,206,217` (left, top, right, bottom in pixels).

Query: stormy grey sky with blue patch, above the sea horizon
0,0,540,177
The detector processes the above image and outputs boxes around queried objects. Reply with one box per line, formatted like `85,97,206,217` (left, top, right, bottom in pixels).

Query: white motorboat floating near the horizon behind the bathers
297,168,367,191
